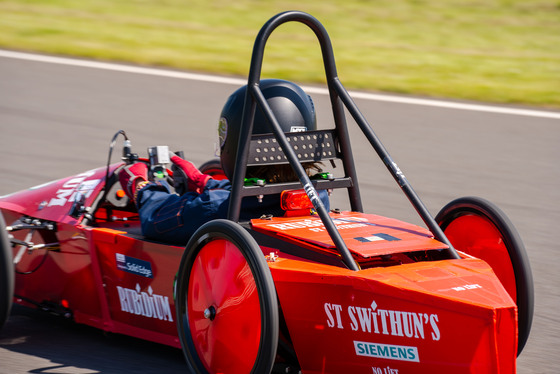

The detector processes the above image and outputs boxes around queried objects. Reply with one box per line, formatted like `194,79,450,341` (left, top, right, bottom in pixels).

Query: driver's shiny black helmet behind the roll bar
218,79,317,179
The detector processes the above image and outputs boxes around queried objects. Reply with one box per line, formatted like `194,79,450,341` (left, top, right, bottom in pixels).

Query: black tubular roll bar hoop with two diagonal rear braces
228,11,459,271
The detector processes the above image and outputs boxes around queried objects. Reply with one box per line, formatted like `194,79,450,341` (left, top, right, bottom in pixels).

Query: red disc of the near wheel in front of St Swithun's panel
187,239,261,373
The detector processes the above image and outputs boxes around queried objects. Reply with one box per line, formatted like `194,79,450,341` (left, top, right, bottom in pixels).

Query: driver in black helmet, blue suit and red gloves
119,79,329,244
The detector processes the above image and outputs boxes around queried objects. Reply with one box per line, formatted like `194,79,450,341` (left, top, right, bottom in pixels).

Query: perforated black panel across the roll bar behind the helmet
247,130,339,166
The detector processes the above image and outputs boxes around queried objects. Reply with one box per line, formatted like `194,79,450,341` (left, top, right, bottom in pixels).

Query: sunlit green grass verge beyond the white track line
0,0,560,108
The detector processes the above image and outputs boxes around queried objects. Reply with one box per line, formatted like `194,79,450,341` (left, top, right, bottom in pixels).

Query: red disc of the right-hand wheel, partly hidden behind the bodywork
444,214,517,303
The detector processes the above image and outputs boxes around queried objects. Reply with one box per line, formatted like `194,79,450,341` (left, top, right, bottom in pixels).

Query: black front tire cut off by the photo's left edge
0,213,14,330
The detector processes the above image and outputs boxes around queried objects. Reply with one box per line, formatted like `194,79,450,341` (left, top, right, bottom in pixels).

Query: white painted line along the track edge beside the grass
0,49,560,119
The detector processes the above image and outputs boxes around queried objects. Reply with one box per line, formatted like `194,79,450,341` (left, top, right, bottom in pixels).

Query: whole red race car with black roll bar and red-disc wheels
0,11,533,374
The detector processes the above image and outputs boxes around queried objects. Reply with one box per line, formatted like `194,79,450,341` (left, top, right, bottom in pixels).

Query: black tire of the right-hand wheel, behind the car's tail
435,197,535,356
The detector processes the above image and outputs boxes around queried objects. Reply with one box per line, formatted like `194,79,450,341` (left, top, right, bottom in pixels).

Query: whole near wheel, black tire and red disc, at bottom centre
175,220,279,373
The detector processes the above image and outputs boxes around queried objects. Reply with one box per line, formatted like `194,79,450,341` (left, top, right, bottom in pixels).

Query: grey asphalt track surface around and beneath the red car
0,53,560,374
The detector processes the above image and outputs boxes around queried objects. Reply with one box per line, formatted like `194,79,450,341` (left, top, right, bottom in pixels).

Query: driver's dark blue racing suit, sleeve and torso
136,179,329,245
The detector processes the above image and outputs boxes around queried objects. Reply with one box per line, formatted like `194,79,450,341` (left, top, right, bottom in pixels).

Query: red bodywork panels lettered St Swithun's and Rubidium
0,161,517,373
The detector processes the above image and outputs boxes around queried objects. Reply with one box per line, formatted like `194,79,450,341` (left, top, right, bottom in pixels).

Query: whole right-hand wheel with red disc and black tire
436,197,534,355
